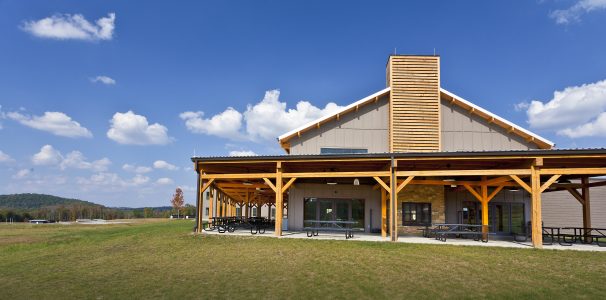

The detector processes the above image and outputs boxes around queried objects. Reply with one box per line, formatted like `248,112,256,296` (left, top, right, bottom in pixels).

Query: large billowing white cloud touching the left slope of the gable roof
180,90,342,142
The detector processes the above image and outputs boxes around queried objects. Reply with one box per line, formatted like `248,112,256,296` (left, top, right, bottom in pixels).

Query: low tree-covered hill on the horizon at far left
0,193,104,209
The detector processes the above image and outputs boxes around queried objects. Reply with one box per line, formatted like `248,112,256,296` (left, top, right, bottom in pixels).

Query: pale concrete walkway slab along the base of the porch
204,230,606,252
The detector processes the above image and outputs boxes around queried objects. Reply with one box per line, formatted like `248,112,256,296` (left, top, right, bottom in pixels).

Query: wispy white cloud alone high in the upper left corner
21,13,116,41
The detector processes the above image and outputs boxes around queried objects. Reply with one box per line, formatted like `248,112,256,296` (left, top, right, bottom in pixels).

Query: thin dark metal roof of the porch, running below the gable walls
191,148,606,162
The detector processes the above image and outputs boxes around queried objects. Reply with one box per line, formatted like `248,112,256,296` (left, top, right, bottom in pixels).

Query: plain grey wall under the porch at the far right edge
541,186,606,228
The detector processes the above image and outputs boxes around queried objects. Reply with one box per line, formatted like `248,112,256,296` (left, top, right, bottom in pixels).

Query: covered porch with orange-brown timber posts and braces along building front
192,149,606,248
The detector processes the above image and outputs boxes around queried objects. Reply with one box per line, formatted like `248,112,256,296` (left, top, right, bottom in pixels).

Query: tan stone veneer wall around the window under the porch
398,185,446,234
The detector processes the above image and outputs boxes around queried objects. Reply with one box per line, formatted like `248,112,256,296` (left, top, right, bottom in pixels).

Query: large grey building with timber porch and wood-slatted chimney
192,55,606,247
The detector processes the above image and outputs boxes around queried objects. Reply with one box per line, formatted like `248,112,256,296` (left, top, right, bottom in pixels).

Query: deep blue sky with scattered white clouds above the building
0,0,606,207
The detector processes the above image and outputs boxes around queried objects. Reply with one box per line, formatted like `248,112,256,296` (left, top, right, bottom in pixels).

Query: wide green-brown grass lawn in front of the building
0,220,606,299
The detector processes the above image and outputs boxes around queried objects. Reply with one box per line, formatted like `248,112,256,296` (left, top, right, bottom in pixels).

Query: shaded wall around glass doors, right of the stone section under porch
446,188,531,230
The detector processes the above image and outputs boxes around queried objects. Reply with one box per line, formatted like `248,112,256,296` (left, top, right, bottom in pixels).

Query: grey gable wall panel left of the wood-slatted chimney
290,96,389,154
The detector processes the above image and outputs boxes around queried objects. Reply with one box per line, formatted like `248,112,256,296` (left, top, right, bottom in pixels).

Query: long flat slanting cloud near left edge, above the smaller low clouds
6,111,93,138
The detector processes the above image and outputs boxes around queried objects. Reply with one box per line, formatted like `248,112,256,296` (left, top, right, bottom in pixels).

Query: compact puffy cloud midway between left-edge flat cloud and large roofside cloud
107,111,172,145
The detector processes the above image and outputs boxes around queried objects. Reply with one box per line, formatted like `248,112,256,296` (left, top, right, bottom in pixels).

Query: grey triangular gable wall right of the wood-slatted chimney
441,99,538,152
